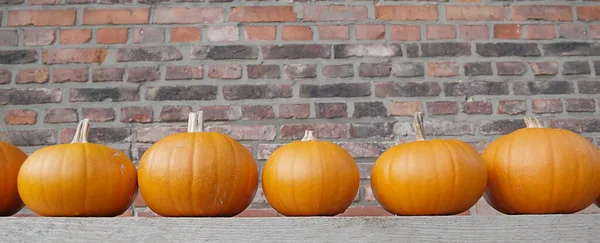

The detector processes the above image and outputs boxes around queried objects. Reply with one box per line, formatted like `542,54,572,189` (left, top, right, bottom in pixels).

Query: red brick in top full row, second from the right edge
510,5,573,21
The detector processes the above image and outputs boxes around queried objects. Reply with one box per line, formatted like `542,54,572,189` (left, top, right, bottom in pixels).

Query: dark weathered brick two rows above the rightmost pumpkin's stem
513,81,581,95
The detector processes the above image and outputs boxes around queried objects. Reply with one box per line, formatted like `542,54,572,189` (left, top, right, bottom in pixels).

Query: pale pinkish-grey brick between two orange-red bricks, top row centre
302,5,369,21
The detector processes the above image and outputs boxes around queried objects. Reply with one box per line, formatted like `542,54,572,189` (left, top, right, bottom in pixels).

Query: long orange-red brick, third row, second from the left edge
42,48,108,64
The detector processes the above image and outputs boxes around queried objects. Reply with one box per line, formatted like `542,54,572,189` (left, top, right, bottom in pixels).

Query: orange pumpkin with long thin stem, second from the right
371,112,487,216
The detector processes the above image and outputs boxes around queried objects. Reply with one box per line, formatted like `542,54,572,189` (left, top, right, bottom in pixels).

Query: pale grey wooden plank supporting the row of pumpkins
0,214,600,243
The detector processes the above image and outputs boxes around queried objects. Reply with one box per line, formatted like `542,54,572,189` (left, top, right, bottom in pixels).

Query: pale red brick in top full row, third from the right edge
446,5,506,21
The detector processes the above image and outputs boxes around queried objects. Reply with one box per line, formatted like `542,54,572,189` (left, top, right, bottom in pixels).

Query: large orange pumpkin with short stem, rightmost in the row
482,117,600,214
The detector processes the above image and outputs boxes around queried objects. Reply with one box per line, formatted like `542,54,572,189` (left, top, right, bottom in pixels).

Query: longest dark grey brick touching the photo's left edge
0,88,62,105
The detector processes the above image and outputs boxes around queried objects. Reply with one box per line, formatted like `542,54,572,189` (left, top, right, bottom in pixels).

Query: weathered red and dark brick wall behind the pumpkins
0,0,600,216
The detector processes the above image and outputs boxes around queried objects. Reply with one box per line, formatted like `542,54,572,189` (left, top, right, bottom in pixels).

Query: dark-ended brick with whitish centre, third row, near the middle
333,44,402,59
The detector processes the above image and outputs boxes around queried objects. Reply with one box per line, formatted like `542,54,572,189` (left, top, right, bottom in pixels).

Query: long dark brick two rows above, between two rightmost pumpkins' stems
444,81,508,96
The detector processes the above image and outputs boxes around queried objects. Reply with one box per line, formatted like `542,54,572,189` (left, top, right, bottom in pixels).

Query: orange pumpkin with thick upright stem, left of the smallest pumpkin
138,111,258,217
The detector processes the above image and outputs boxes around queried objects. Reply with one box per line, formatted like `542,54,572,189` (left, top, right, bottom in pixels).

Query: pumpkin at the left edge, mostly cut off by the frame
0,141,27,216
